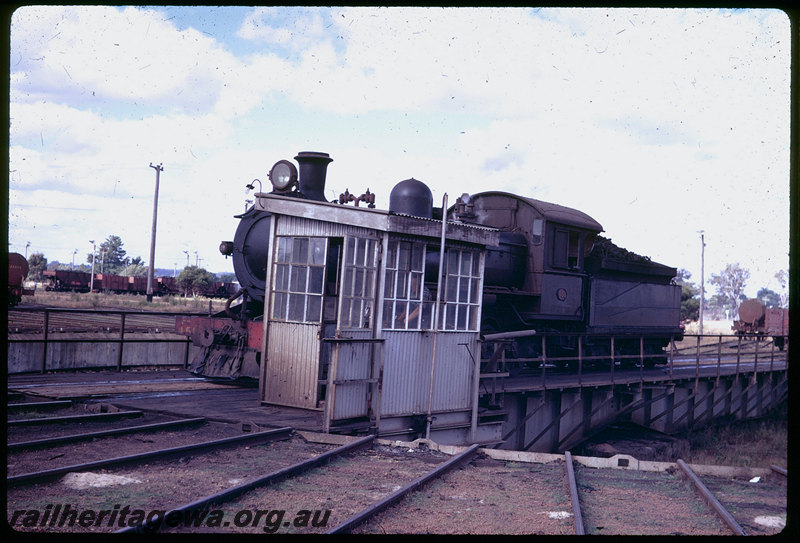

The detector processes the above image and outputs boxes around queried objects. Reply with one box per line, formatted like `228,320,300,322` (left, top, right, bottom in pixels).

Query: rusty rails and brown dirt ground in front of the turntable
7,397,786,535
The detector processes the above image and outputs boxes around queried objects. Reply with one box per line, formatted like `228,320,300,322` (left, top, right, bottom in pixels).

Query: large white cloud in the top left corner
12,6,241,111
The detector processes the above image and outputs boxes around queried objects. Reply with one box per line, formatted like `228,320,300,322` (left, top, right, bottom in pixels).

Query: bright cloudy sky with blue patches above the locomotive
8,6,790,302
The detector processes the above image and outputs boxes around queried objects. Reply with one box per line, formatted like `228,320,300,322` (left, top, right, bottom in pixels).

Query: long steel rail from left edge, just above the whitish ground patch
6,427,292,486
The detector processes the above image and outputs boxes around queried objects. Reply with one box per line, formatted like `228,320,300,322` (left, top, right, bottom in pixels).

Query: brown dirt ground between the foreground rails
6,404,786,536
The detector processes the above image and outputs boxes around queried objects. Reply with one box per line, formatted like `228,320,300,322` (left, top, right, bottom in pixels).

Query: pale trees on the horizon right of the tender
675,262,789,322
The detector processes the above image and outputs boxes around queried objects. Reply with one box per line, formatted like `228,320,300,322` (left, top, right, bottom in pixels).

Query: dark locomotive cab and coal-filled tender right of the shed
450,192,681,367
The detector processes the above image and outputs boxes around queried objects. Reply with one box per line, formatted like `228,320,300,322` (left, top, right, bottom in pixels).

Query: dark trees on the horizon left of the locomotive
21,235,236,296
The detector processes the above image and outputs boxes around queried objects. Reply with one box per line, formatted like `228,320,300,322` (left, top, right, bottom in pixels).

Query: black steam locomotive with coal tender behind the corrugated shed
177,152,683,378
